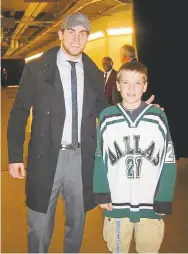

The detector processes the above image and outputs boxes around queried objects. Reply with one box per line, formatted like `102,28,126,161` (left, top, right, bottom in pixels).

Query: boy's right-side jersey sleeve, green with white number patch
154,113,176,214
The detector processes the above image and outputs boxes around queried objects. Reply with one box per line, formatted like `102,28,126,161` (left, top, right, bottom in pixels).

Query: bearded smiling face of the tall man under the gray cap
58,26,89,57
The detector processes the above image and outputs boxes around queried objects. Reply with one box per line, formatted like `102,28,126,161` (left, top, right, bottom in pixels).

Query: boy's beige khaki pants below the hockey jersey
103,217,164,253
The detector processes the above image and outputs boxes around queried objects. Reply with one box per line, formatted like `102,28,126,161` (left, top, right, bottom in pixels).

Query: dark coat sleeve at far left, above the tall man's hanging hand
7,62,36,163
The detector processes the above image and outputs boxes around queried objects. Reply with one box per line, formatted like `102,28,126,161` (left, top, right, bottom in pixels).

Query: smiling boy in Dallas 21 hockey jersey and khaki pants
94,62,176,253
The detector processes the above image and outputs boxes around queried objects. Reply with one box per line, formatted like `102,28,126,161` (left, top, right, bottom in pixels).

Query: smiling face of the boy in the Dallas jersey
117,70,147,108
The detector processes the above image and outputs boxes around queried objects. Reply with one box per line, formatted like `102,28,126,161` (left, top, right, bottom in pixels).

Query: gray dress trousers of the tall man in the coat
28,148,85,253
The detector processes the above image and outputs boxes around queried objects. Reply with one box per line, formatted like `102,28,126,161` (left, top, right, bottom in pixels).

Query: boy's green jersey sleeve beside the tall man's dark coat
93,114,111,204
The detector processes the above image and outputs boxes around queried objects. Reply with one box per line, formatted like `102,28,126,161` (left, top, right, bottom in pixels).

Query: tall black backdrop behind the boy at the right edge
133,0,188,158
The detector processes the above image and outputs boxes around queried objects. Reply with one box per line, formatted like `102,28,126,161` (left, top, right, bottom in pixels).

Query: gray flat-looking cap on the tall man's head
61,12,91,33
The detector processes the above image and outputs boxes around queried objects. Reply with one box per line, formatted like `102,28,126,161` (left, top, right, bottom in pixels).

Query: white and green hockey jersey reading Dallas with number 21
94,104,176,222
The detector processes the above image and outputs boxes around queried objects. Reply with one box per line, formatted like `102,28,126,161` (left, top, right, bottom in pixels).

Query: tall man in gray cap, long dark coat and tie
8,13,106,253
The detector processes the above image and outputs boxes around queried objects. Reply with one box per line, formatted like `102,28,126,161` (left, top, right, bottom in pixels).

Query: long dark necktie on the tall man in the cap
68,61,78,149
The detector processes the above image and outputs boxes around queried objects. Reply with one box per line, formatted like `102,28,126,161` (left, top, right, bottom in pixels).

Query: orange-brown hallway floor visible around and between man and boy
1,88,188,253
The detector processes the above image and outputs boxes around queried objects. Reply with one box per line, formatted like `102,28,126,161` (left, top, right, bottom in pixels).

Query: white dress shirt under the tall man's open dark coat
57,48,84,145
